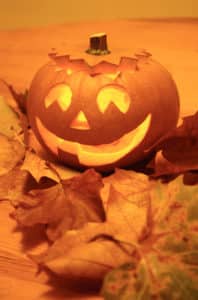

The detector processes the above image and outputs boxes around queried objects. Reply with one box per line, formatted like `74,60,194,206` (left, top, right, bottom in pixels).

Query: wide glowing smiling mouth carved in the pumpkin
36,114,151,167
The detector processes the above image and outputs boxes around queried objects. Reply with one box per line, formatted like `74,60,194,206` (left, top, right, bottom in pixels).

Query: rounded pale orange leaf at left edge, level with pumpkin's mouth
0,134,25,176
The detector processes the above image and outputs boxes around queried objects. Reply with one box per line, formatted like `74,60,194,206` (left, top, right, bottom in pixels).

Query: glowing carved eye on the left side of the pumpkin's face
45,84,72,111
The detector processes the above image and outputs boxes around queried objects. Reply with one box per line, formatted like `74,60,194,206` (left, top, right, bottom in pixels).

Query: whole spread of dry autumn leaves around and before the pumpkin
0,81,198,300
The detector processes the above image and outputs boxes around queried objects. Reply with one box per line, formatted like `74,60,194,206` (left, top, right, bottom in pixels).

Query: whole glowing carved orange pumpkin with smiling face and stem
27,34,179,171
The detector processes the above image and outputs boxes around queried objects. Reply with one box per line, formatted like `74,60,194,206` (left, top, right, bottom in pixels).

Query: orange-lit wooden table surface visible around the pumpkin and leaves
0,20,198,300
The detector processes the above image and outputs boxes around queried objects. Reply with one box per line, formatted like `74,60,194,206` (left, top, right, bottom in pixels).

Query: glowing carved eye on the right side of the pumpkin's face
97,86,131,114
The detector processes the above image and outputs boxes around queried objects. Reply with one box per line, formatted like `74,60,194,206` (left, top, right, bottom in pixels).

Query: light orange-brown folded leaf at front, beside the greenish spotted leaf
32,223,134,285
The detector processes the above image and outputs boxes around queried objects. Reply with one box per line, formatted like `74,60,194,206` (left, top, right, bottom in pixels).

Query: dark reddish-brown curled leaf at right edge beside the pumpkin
150,112,198,176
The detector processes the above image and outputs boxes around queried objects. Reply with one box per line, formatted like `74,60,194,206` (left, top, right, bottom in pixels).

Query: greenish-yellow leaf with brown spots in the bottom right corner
102,176,198,300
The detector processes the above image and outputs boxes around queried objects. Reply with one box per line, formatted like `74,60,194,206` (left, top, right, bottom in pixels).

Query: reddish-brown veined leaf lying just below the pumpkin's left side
15,170,104,240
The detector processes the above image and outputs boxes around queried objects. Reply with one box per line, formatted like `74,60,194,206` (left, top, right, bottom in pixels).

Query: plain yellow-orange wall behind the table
0,0,198,28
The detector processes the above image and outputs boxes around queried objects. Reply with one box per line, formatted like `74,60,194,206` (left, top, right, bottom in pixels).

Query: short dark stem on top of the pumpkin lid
86,33,110,55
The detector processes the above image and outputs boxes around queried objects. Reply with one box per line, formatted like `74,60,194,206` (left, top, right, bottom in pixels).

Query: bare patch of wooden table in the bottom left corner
0,201,101,300
